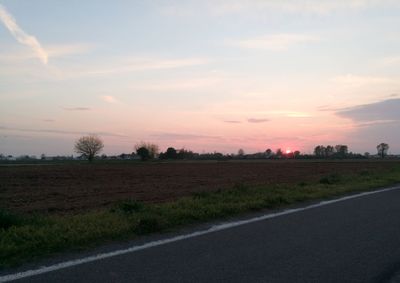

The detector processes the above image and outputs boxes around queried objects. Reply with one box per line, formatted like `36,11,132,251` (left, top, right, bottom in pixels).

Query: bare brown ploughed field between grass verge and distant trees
0,161,395,213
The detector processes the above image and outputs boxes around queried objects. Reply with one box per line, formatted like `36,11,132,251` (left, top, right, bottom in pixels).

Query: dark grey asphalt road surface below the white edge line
7,187,400,283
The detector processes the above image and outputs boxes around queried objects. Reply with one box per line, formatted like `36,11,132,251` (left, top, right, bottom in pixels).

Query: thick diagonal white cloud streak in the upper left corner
0,4,49,64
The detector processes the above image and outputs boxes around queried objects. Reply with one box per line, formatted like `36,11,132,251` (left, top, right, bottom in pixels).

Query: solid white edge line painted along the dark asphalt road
0,187,400,282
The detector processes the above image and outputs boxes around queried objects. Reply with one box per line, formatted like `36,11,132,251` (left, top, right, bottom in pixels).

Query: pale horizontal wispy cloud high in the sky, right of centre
228,33,318,51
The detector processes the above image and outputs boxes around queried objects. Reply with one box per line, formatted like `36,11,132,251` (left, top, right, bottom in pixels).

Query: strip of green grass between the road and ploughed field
0,166,400,269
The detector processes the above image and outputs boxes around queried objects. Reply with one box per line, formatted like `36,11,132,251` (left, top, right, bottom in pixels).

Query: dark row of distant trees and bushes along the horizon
70,135,389,161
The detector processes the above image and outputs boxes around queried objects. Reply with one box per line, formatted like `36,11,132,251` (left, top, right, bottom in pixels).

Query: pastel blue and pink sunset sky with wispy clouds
0,0,400,155
